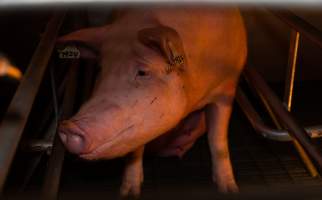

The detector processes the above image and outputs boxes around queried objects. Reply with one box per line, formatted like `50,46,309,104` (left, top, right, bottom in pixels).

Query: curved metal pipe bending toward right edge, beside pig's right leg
236,88,322,142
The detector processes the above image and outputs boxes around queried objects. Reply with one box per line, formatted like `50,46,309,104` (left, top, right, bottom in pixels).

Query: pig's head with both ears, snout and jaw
59,25,187,159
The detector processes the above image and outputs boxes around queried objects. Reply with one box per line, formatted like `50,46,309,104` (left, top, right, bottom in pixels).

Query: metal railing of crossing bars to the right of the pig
236,10,322,177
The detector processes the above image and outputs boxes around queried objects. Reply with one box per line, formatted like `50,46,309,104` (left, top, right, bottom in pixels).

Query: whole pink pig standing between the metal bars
58,6,247,196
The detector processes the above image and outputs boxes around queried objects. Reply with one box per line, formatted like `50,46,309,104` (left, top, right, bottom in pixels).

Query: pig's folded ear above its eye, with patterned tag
138,25,187,73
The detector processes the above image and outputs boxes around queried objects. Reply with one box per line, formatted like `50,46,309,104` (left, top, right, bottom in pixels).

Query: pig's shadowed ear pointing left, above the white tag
56,26,107,59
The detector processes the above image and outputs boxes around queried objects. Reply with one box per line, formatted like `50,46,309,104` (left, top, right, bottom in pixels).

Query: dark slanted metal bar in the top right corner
269,9,322,48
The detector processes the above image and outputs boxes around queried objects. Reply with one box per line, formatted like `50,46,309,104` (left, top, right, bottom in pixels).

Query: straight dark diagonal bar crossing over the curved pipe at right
244,67,322,168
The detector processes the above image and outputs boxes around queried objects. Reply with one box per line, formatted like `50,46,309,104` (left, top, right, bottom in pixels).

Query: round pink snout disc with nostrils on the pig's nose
59,121,88,154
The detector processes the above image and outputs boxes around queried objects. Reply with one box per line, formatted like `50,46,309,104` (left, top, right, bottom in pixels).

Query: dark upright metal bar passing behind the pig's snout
42,61,78,199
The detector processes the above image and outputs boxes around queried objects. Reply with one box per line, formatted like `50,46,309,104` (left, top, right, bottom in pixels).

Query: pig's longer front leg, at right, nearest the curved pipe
206,97,238,192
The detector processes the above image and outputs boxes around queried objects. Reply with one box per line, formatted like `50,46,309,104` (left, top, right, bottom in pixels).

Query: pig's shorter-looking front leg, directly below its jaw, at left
120,146,144,197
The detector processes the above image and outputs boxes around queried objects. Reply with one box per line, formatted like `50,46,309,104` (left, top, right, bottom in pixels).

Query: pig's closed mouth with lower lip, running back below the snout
79,124,135,160
